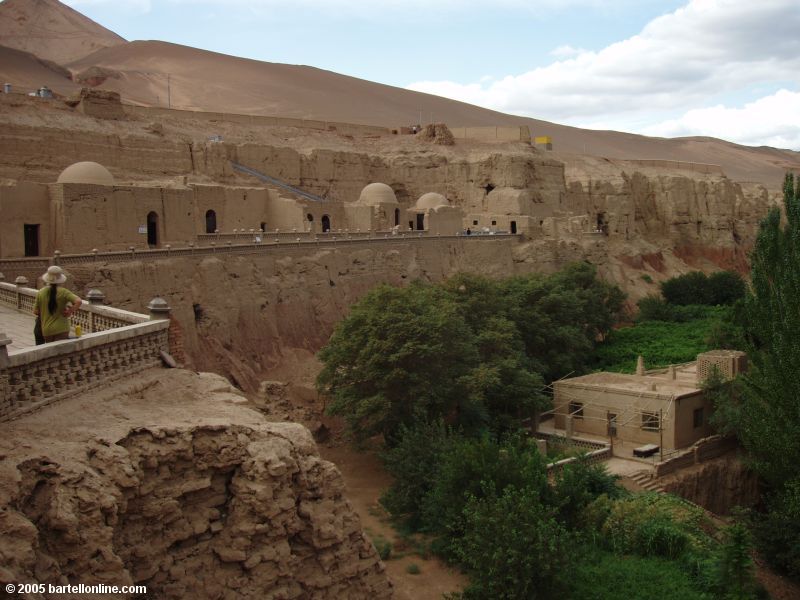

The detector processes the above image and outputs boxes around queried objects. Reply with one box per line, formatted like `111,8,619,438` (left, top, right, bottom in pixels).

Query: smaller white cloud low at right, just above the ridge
644,90,800,148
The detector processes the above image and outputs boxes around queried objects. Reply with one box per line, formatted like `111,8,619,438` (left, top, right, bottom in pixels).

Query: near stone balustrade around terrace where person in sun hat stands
0,282,171,421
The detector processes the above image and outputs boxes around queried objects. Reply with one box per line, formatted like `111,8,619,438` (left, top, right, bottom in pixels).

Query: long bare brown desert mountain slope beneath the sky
0,0,800,185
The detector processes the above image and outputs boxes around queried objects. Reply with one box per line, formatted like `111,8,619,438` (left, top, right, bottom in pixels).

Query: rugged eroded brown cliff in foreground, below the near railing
0,370,391,599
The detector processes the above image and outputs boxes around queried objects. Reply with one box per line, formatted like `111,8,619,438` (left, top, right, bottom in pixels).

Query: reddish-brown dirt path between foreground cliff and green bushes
319,445,467,600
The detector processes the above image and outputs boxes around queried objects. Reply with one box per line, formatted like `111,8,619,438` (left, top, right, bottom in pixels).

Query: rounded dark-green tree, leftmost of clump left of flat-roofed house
317,283,478,442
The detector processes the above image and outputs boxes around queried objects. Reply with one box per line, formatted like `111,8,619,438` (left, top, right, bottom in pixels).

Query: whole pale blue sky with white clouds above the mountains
65,0,800,150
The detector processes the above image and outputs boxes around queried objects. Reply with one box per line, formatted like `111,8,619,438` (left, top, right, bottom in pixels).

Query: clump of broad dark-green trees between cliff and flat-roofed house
317,263,624,444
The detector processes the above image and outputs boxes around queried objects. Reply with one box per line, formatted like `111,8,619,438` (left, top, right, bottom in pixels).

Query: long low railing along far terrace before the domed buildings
0,231,521,278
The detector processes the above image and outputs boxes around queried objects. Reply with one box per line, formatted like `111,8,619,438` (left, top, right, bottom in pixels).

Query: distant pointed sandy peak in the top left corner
0,0,125,64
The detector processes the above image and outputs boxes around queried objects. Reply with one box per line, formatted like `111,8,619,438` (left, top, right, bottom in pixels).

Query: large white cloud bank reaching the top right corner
408,0,800,147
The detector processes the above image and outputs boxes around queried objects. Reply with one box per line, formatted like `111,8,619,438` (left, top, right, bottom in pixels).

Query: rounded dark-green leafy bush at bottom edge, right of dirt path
457,487,572,600
